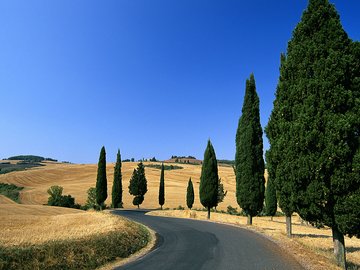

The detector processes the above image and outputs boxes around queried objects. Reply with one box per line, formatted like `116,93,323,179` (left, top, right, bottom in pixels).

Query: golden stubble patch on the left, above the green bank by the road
0,197,134,246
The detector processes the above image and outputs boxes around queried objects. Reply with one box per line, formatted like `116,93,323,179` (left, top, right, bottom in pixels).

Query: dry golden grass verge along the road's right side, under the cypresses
147,210,360,270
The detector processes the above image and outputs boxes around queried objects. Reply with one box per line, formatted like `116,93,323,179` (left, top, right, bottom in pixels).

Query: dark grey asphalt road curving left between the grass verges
113,210,304,270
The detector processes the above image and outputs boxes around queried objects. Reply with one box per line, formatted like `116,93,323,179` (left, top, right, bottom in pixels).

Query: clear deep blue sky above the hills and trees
0,0,360,163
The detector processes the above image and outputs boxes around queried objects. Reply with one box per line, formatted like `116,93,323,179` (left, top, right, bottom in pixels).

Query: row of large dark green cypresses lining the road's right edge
200,0,360,269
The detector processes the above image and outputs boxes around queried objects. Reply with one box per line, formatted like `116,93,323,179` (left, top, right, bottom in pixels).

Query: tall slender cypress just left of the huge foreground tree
235,74,265,225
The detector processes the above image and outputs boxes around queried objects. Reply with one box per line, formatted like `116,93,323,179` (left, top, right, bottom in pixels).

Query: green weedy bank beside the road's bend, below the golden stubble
0,223,151,270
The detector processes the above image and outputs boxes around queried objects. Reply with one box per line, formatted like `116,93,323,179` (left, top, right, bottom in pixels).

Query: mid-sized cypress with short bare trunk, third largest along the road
199,140,219,219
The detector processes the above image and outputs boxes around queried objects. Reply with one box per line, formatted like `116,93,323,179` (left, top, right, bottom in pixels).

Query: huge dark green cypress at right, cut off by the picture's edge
267,0,360,269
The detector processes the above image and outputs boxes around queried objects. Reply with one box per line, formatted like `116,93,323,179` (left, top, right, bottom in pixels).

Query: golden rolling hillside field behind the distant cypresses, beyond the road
0,162,242,210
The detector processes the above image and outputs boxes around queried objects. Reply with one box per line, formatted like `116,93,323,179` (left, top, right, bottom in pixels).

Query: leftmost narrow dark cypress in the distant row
96,146,107,210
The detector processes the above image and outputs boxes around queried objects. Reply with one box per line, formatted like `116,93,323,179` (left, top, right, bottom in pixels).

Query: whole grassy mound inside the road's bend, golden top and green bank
0,209,151,269
